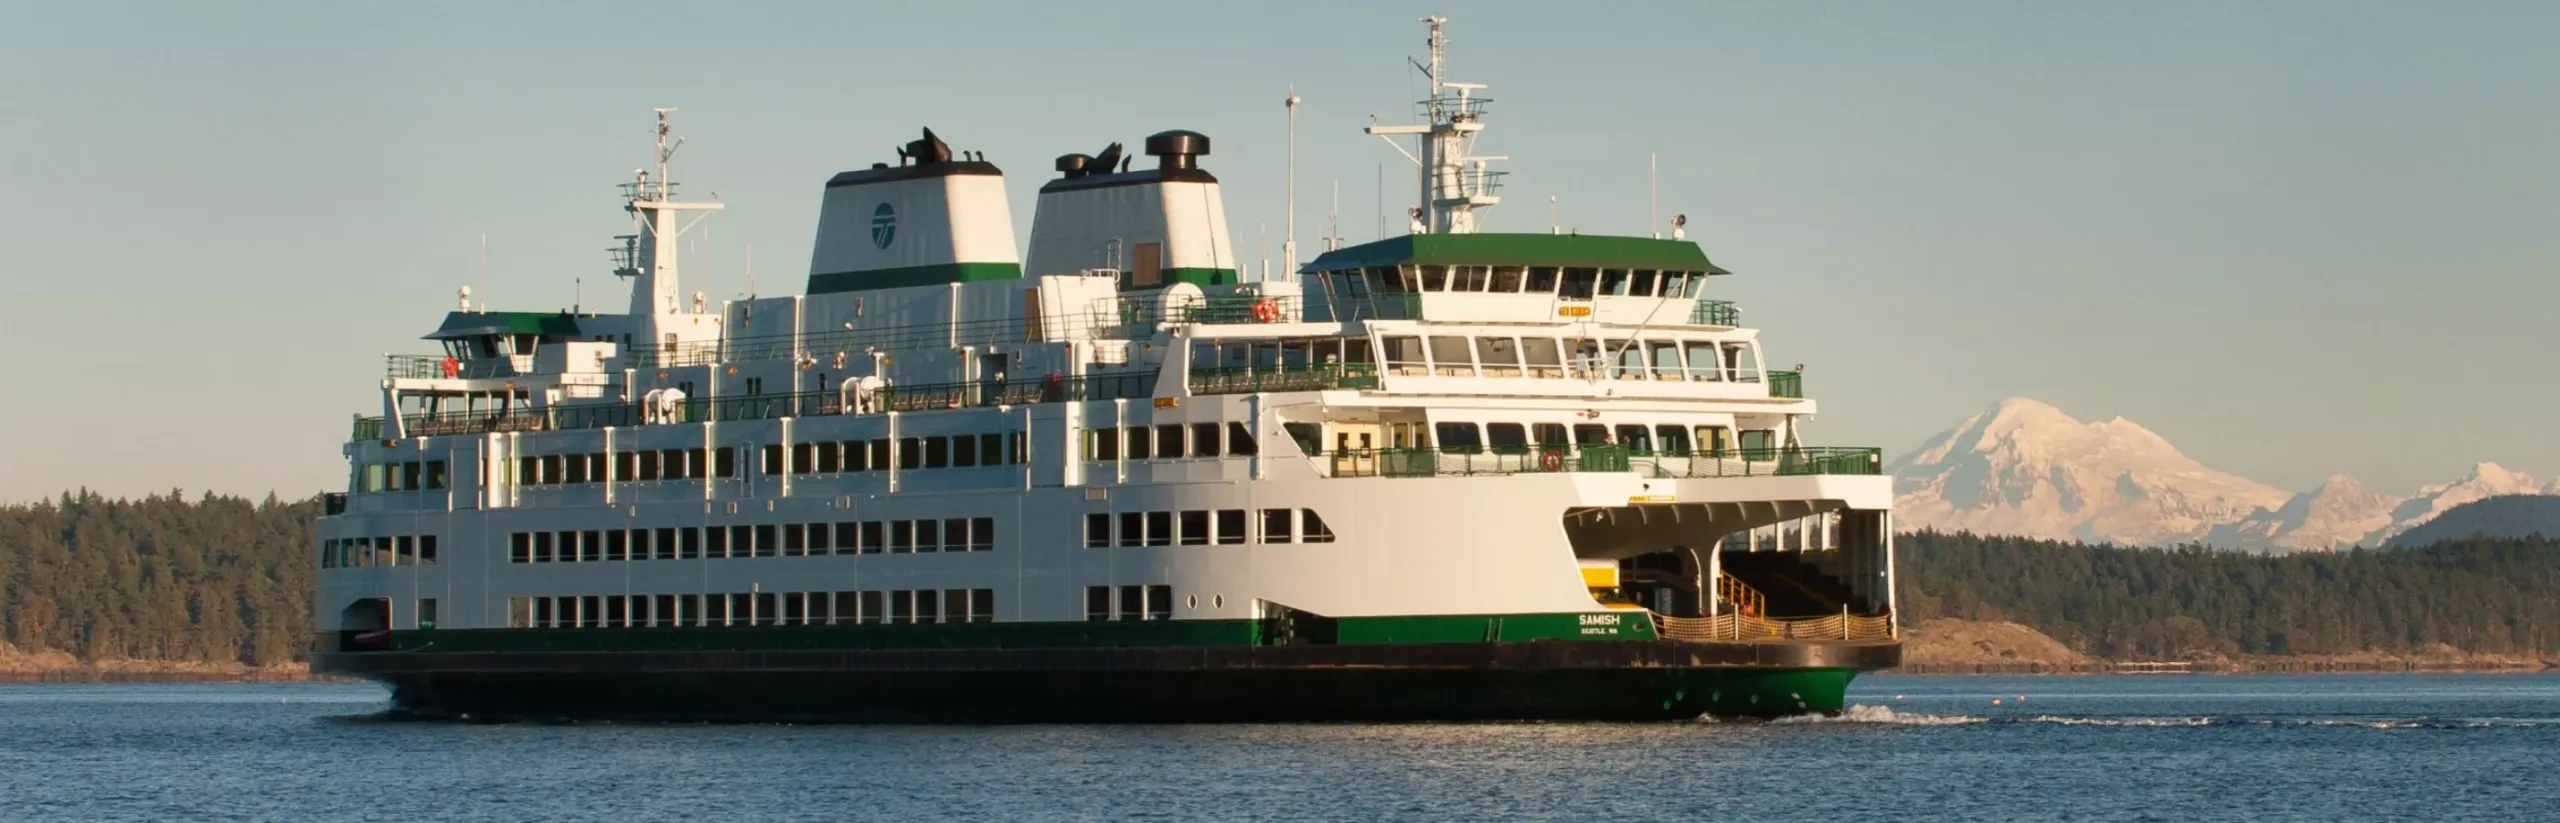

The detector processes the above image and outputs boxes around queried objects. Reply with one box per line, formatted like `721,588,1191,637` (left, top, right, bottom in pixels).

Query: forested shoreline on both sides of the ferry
0,492,2560,669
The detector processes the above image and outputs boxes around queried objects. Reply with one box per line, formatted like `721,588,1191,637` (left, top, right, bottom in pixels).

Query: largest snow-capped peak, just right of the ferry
1892,397,2289,546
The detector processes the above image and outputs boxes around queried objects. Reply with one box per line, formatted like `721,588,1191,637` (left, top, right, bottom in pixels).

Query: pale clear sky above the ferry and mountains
0,0,2560,500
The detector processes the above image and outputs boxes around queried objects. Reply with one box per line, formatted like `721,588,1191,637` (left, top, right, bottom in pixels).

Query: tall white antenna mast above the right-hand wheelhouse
1367,15,1510,233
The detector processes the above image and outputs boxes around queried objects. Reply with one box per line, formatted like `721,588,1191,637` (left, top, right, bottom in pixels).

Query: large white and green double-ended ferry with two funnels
312,18,1902,723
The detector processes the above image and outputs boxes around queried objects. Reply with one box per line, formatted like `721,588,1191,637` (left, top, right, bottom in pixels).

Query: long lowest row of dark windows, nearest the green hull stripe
507,590,998,628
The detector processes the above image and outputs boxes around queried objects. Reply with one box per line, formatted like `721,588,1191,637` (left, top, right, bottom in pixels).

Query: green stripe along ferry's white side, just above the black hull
384,613,1654,651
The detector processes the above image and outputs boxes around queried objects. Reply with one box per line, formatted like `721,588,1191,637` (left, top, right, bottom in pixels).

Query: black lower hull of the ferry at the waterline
315,641,1902,723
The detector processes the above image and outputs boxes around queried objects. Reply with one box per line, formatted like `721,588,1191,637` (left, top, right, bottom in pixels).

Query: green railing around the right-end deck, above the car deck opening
1316,446,1884,477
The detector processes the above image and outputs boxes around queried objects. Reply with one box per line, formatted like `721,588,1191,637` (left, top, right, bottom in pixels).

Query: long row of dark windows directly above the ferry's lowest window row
507,518,996,564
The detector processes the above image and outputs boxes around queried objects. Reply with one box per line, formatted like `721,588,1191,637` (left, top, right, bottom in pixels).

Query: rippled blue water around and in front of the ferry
0,674,2560,823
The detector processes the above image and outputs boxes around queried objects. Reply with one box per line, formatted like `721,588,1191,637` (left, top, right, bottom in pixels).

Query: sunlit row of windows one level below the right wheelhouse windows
1377,336,1761,382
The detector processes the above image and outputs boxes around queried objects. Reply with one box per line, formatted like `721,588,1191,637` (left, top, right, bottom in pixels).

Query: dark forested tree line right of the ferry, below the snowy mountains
1894,533,2560,659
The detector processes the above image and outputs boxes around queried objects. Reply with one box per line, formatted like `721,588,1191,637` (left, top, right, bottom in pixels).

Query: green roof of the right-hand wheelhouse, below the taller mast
1300,233,1733,274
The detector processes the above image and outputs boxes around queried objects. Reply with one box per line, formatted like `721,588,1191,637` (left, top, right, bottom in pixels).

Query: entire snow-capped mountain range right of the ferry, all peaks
1889,397,2560,551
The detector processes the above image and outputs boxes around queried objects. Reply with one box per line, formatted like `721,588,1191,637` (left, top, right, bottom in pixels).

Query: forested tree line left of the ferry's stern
0,490,320,667
